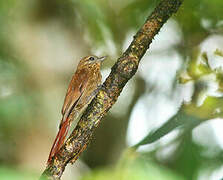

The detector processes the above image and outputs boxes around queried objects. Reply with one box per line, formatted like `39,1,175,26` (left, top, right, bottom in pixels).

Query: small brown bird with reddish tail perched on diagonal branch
47,55,107,164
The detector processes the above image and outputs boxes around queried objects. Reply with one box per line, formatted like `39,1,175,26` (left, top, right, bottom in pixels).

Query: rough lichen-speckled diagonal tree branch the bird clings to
41,0,183,180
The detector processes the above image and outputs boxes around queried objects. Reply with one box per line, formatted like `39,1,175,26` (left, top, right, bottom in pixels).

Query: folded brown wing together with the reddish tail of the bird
48,69,88,163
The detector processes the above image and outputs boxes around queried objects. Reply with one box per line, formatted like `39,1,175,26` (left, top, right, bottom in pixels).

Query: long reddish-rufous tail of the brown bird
47,117,70,164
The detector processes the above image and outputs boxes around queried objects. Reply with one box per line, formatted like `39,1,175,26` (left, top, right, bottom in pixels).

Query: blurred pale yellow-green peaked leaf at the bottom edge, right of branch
82,149,184,180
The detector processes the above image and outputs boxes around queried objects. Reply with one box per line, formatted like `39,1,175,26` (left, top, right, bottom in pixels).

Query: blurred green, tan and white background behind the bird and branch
0,0,223,180
